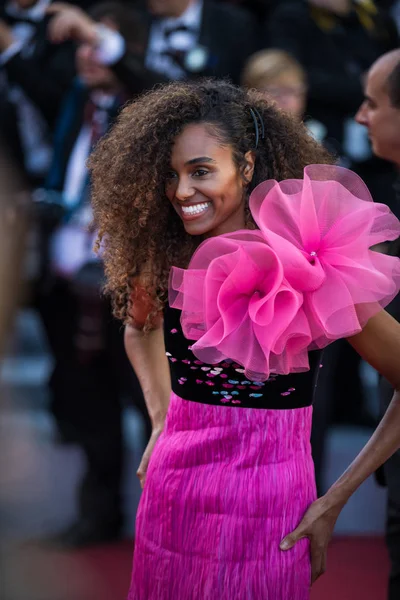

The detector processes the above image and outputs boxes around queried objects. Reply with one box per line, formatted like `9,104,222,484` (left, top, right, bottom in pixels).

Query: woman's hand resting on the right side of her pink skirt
280,497,341,584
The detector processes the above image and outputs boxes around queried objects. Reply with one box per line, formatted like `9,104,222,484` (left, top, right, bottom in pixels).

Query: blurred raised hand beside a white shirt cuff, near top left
46,2,98,45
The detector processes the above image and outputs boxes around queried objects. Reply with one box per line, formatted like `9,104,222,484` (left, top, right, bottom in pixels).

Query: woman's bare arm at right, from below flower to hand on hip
281,311,400,581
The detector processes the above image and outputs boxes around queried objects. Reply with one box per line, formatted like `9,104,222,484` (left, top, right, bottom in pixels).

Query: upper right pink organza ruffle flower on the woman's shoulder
250,165,400,348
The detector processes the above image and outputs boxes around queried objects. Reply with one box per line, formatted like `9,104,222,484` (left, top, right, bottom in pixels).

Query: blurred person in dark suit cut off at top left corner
0,0,75,188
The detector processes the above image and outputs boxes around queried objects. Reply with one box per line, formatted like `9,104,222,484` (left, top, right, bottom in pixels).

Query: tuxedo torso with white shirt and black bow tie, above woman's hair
145,0,259,83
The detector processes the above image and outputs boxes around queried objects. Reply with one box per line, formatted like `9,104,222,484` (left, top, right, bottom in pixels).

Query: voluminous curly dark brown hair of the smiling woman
89,80,333,322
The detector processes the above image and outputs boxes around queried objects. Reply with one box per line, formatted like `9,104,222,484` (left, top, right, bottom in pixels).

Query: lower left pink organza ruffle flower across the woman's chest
170,231,311,381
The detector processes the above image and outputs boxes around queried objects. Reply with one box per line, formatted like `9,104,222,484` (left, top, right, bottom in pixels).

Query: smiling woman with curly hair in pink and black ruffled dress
90,81,400,600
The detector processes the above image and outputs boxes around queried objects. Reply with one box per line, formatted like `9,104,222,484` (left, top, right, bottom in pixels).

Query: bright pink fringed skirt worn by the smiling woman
128,394,316,600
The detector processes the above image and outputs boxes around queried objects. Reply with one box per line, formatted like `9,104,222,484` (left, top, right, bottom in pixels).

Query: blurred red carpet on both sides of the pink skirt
5,538,389,600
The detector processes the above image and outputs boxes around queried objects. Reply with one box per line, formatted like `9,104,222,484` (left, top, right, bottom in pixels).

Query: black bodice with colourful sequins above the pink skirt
164,307,322,409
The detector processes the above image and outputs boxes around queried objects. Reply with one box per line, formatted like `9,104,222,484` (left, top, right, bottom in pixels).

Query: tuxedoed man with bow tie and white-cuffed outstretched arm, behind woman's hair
51,0,260,89
